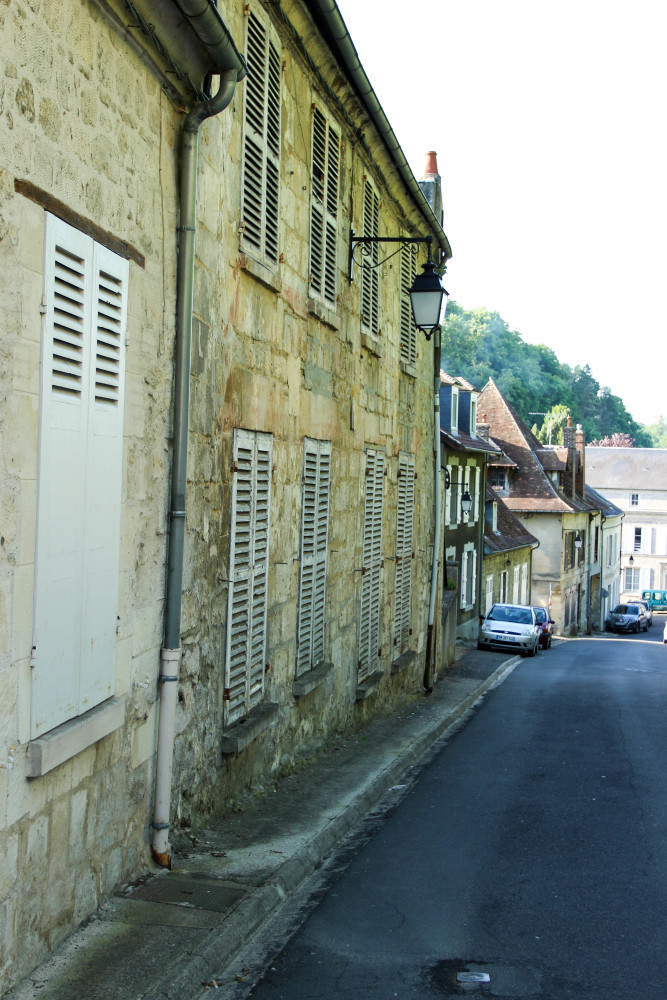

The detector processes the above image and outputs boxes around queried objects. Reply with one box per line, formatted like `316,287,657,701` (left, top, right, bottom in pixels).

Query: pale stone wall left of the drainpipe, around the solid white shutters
0,0,180,993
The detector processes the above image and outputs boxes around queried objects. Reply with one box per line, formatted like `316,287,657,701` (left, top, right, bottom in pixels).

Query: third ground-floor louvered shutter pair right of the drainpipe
359,449,384,681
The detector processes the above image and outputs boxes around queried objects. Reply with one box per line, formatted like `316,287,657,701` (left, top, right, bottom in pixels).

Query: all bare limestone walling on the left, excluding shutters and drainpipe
0,0,448,992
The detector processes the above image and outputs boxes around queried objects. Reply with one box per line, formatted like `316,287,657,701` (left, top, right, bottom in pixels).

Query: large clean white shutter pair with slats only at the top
31,214,128,738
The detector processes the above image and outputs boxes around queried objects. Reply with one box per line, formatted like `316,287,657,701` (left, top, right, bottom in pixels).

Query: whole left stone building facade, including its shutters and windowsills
0,0,450,992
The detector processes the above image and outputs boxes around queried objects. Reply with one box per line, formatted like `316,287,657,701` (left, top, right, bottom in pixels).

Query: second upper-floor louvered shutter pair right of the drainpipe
310,108,340,308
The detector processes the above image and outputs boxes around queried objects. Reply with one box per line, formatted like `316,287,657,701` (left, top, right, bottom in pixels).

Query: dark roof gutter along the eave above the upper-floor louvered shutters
309,0,452,270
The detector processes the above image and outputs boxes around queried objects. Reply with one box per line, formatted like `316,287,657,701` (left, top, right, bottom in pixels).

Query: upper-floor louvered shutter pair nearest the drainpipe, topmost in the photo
242,12,280,265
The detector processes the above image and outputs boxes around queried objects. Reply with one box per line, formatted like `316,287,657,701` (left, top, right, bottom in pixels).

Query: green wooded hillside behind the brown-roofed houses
442,302,653,448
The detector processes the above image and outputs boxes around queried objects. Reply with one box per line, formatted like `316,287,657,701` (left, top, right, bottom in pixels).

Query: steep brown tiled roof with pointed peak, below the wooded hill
478,379,598,513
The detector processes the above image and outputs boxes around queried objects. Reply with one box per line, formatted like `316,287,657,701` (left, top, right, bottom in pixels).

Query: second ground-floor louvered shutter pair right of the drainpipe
296,438,331,677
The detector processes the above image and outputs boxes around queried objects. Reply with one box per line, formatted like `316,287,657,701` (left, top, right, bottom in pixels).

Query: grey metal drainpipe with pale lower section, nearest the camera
152,69,239,868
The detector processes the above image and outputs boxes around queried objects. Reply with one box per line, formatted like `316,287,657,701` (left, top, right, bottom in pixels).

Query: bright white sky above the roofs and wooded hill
338,0,667,423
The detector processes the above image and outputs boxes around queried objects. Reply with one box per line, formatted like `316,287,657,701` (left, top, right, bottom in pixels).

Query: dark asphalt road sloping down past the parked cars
234,616,667,1000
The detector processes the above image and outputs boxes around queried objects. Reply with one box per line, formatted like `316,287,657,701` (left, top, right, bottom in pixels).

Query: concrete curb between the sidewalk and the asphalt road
145,656,521,1000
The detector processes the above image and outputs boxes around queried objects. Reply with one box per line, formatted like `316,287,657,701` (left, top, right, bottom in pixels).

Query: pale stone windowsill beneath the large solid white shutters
27,695,125,778
